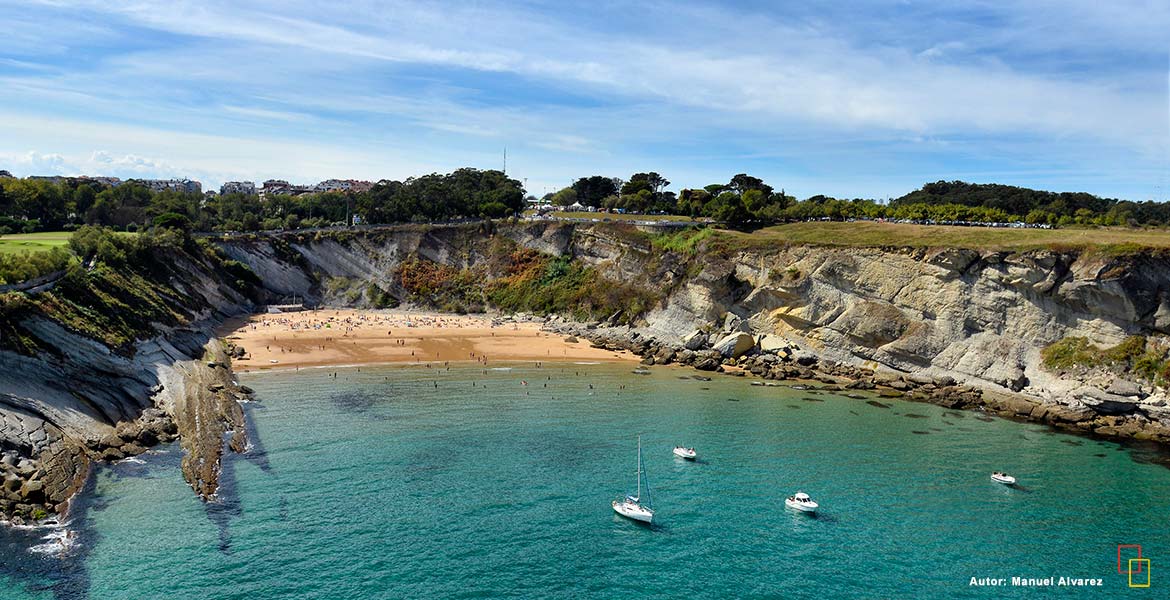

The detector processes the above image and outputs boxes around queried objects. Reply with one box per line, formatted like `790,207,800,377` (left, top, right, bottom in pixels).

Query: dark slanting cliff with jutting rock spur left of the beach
0,234,253,522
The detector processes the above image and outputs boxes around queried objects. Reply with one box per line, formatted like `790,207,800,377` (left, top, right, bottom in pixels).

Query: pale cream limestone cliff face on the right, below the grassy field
646,247,1170,391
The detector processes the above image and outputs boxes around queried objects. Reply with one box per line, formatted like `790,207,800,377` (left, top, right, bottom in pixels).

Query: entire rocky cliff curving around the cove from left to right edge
0,222,1170,519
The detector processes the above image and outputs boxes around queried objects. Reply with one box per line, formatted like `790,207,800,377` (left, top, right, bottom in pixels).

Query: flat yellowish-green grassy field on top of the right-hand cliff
728,221,1170,251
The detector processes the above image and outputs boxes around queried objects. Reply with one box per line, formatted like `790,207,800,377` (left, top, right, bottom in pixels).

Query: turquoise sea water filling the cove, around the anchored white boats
0,364,1170,599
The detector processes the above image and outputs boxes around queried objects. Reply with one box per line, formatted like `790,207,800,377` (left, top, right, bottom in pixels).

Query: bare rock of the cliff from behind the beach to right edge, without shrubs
225,223,1170,437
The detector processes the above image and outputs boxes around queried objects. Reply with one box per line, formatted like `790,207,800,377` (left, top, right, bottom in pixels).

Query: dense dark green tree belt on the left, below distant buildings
0,168,524,234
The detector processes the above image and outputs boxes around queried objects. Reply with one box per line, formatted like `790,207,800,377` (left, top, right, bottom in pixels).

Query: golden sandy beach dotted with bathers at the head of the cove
218,309,638,372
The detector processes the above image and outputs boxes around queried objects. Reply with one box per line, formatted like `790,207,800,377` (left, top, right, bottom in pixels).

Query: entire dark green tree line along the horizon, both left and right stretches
0,168,1170,234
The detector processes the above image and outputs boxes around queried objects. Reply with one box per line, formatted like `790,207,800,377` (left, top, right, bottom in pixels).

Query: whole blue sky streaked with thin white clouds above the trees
0,0,1170,200
